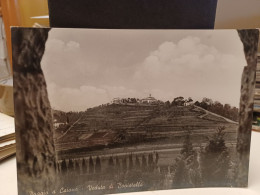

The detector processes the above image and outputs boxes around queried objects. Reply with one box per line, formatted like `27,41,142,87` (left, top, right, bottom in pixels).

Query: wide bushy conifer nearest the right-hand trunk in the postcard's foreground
201,127,230,187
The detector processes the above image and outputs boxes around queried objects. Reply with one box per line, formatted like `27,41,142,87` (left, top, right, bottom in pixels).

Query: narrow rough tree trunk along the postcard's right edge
237,29,259,186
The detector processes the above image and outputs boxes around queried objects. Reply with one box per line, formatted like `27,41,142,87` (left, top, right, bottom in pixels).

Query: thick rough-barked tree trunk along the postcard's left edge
12,28,57,194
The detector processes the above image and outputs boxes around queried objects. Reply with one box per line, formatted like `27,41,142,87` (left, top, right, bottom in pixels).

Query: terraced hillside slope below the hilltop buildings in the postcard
54,104,238,159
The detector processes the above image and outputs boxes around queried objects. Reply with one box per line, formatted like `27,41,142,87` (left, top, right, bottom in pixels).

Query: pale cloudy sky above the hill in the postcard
42,29,246,111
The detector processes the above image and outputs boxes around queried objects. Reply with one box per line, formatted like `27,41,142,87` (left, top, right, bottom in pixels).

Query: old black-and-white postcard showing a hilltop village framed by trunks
12,28,254,195
